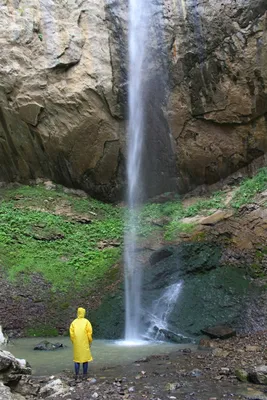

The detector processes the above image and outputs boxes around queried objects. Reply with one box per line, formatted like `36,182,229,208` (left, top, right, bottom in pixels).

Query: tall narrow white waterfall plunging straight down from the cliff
125,0,150,342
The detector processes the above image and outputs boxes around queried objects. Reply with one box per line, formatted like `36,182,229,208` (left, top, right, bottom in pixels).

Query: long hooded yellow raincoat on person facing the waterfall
70,307,93,363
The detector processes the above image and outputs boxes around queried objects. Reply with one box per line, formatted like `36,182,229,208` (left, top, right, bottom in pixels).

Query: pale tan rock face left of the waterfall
0,0,124,197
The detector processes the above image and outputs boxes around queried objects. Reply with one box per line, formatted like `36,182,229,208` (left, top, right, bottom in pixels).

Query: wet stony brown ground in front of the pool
49,332,267,400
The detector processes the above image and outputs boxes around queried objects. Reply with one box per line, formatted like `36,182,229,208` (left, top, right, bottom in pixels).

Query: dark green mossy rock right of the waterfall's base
143,243,261,337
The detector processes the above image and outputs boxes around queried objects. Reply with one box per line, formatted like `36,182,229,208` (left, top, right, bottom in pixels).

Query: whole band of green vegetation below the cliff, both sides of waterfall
0,168,267,291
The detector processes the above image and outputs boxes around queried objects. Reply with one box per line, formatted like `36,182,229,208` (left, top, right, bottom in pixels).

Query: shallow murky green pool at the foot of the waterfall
1,337,194,375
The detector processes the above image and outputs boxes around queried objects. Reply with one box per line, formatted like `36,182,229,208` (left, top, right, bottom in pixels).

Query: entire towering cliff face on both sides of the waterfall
0,0,267,200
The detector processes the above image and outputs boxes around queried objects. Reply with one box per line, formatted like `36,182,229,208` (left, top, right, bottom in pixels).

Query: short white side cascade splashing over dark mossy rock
146,282,182,339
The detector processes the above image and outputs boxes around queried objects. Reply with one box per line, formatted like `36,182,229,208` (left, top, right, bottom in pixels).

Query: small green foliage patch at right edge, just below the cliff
231,168,267,209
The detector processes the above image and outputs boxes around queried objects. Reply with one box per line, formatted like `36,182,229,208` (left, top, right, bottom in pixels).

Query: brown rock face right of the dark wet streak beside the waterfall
167,0,267,190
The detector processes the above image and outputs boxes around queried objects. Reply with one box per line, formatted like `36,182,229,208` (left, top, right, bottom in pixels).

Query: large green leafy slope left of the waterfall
0,187,123,291
